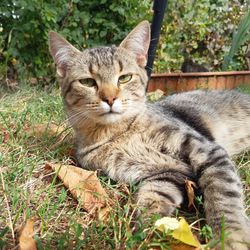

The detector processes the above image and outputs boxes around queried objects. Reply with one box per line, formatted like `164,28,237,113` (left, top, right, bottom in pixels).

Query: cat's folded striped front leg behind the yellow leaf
137,165,193,216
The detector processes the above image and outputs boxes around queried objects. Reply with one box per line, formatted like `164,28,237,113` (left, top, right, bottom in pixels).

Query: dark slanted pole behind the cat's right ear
146,0,167,83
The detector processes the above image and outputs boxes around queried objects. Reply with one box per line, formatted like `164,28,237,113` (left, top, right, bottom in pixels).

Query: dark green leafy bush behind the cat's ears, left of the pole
0,0,151,83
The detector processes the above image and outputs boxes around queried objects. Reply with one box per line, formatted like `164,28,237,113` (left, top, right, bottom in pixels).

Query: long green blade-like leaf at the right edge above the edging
222,10,250,70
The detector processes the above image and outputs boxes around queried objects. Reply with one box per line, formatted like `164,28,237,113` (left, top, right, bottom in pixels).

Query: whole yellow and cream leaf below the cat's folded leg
155,217,200,249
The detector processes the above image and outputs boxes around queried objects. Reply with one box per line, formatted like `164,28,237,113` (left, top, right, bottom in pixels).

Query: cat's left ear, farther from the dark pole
49,31,80,77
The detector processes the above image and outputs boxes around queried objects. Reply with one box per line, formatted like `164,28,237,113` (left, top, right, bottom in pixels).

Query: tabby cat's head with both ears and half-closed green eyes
49,21,150,125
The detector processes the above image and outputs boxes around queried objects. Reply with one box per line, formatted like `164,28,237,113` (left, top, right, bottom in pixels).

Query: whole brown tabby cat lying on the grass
49,21,250,250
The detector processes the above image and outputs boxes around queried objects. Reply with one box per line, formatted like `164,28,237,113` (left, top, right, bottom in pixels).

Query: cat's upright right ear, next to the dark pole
120,21,150,67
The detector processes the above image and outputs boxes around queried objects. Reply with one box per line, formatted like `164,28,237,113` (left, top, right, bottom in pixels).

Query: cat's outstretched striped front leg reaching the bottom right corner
179,134,250,250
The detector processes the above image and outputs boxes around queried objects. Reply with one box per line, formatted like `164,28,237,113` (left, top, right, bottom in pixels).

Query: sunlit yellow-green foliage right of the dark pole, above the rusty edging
155,0,248,72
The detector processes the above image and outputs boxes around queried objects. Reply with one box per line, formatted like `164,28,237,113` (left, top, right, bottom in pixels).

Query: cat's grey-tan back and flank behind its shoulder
156,90,250,155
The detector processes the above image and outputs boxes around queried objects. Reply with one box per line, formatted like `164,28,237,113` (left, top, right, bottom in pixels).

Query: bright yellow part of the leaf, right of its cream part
172,218,200,247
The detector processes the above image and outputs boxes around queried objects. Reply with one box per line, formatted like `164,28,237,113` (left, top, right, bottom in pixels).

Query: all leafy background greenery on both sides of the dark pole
0,0,249,86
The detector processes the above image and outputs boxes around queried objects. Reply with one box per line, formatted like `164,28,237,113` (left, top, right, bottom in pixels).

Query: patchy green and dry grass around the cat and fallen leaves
0,85,250,250
